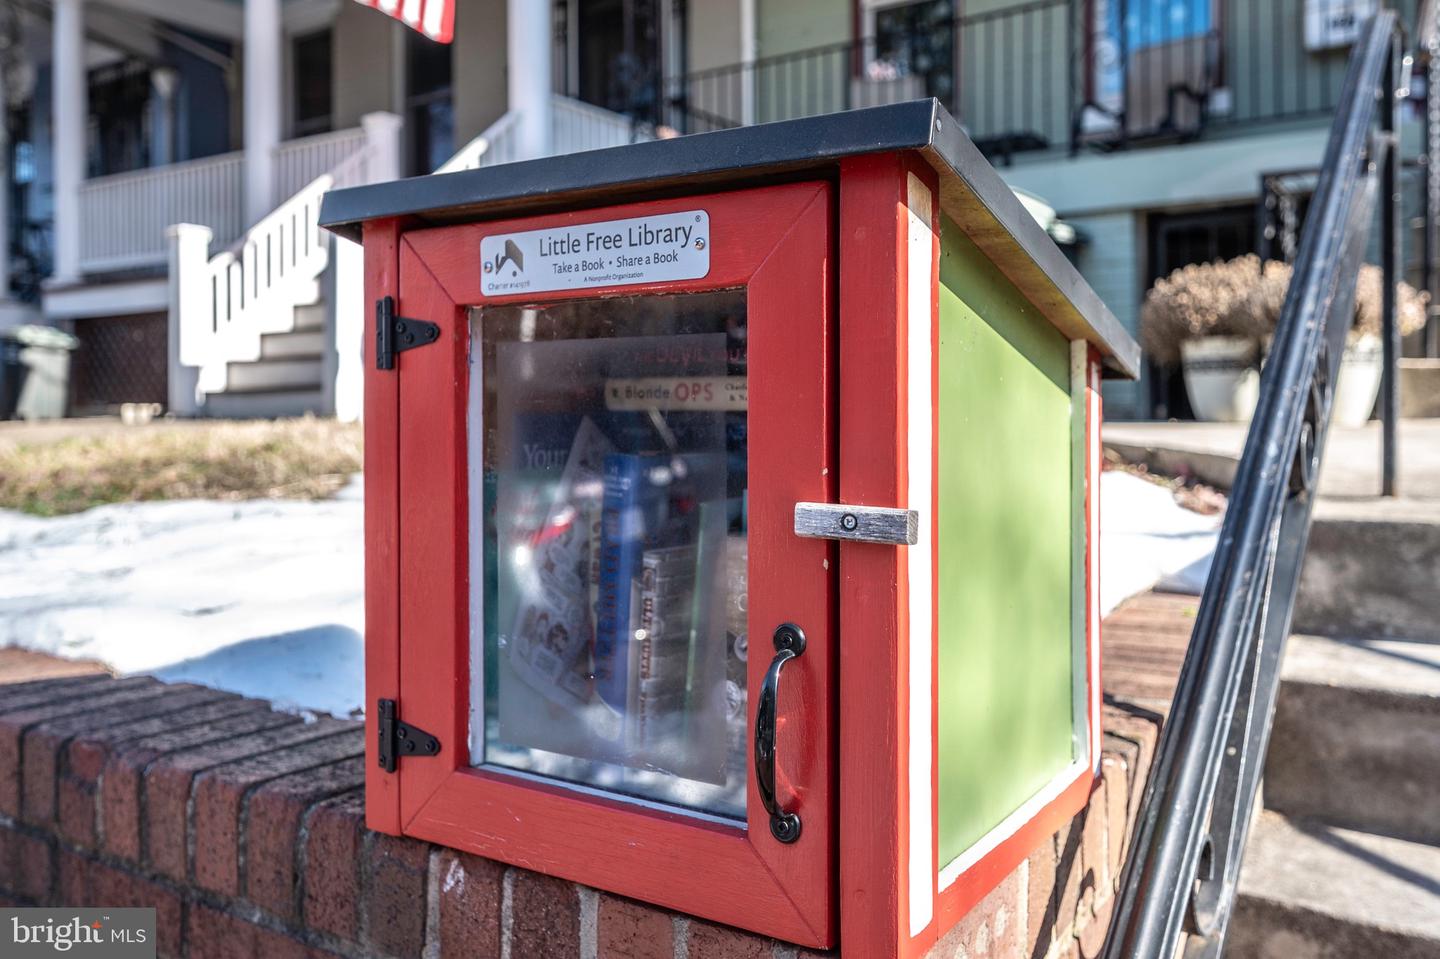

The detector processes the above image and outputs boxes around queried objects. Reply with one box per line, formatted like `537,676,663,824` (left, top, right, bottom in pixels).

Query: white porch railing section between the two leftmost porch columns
79,151,245,272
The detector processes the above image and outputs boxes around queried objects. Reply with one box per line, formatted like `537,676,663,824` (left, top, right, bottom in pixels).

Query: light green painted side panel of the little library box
936,219,1074,867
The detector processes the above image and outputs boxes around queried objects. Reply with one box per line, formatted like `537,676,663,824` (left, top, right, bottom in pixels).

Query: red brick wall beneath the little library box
0,596,1194,959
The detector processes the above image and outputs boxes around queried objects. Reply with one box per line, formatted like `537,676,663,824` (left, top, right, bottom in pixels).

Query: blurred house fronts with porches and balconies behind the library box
0,0,1428,419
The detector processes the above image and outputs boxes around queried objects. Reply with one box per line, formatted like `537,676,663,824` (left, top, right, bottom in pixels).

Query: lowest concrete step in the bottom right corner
1224,812,1440,959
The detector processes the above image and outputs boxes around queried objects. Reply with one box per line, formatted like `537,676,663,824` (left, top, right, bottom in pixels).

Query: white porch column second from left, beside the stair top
242,0,282,223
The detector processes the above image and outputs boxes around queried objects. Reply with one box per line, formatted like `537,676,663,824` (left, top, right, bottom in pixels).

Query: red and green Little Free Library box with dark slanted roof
321,101,1139,959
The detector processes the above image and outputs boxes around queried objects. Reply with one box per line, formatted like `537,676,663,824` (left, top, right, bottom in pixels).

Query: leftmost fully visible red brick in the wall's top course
23,683,221,829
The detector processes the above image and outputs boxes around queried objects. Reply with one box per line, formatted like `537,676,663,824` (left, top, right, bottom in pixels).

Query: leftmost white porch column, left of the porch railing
50,0,89,284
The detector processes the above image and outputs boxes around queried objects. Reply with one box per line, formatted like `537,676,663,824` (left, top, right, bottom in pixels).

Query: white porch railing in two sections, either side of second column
81,128,366,274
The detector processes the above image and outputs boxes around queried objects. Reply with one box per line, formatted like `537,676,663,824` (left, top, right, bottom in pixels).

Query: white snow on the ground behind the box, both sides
0,472,1220,716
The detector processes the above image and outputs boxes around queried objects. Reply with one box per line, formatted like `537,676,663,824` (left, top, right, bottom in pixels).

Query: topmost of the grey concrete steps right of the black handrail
1293,498,1440,642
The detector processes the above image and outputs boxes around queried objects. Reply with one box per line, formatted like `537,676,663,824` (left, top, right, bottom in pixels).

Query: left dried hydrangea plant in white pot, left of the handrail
1140,256,1263,422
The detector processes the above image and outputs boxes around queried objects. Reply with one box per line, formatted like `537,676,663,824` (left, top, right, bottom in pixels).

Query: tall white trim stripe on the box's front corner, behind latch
904,173,936,936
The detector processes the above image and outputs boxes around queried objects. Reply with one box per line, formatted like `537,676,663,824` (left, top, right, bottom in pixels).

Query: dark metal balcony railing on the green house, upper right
664,0,1416,160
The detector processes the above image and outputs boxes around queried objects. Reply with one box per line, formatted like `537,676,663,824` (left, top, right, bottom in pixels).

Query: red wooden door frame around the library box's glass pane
367,181,838,947
